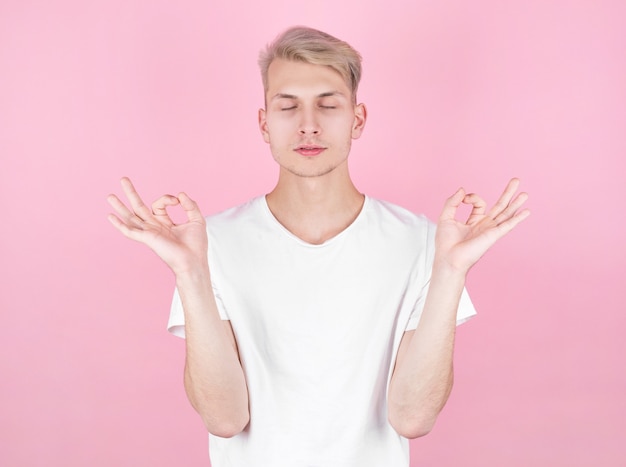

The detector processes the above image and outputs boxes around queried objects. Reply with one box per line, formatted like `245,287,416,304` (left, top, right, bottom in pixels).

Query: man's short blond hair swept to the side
259,26,361,101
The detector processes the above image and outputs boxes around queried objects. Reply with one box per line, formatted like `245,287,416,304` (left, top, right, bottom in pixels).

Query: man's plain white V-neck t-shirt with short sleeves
168,196,475,467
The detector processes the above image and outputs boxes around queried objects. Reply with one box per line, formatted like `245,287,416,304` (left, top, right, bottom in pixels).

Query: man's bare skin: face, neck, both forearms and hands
108,60,529,438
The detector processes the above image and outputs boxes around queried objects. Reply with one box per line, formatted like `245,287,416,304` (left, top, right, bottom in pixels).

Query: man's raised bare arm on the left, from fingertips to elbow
107,177,250,438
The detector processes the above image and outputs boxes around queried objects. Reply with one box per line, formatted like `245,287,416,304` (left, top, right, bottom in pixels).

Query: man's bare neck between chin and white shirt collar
266,166,365,244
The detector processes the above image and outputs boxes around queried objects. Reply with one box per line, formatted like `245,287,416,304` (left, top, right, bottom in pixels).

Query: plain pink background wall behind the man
0,0,626,467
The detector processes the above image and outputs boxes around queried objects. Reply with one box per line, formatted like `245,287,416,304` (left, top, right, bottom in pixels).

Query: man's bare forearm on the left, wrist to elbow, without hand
176,268,249,437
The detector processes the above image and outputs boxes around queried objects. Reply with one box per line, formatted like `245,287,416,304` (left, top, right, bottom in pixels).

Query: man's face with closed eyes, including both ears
259,59,366,177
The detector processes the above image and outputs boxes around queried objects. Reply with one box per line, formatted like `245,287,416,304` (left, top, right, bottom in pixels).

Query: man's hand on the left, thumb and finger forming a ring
107,177,208,275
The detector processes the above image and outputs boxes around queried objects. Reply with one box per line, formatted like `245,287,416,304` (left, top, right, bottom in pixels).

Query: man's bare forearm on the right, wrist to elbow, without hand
388,261,465,438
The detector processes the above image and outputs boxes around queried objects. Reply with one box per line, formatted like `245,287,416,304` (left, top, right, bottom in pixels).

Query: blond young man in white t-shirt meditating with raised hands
109,28,528,467
